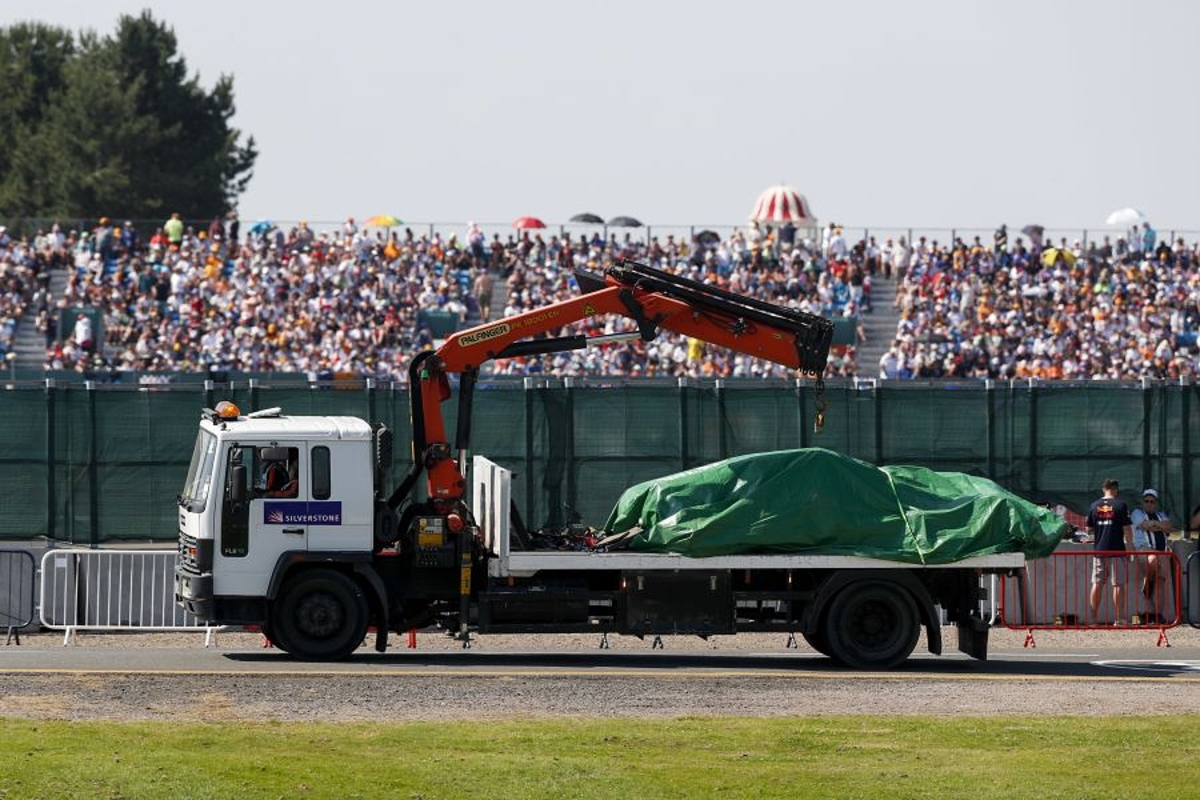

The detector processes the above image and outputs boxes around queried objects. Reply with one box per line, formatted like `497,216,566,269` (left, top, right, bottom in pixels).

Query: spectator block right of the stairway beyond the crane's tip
877,223,1200,380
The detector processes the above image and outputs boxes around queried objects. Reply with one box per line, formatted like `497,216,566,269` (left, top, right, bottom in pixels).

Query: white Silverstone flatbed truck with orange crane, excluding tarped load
175,261,1025,668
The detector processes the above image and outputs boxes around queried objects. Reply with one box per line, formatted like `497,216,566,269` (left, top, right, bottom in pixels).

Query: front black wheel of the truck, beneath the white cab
270,570,368,661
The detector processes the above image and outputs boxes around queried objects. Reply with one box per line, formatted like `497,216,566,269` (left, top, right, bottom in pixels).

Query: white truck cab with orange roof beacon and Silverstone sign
175,403,374,624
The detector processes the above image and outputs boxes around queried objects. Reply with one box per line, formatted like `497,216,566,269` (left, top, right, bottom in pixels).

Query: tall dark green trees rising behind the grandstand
0,12,258,224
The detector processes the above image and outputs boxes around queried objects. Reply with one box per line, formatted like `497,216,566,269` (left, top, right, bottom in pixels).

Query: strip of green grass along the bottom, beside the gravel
0,715,1200,800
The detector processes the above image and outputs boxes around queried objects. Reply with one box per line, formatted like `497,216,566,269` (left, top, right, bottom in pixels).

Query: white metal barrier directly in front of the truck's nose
41,549,218,646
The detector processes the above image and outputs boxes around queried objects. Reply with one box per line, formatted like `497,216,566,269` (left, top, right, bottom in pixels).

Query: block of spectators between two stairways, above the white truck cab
18,218,470,379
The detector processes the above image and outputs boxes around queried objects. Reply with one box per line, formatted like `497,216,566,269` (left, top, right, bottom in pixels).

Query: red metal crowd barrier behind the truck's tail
1000,551,1192,646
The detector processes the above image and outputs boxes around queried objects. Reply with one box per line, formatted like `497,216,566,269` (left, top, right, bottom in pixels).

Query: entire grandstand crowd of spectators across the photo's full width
7,215,1200,380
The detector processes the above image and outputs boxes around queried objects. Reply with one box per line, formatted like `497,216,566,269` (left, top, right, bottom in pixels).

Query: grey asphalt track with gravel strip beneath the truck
0,631,1200,721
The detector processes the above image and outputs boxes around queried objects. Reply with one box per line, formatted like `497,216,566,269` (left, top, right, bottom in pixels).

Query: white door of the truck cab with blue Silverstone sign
214,443,308,596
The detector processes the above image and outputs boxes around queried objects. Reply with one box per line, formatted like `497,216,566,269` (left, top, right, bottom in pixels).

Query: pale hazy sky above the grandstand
9,0,1200,231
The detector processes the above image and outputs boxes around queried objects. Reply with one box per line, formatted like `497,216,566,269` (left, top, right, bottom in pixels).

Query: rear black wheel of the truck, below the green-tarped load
824,582,920,669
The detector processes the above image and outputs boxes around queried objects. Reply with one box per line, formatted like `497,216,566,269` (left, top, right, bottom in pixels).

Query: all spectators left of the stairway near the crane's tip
6,215,862,380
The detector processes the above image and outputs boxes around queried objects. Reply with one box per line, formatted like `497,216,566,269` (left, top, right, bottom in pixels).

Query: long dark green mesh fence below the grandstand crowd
0,379,1200,546
